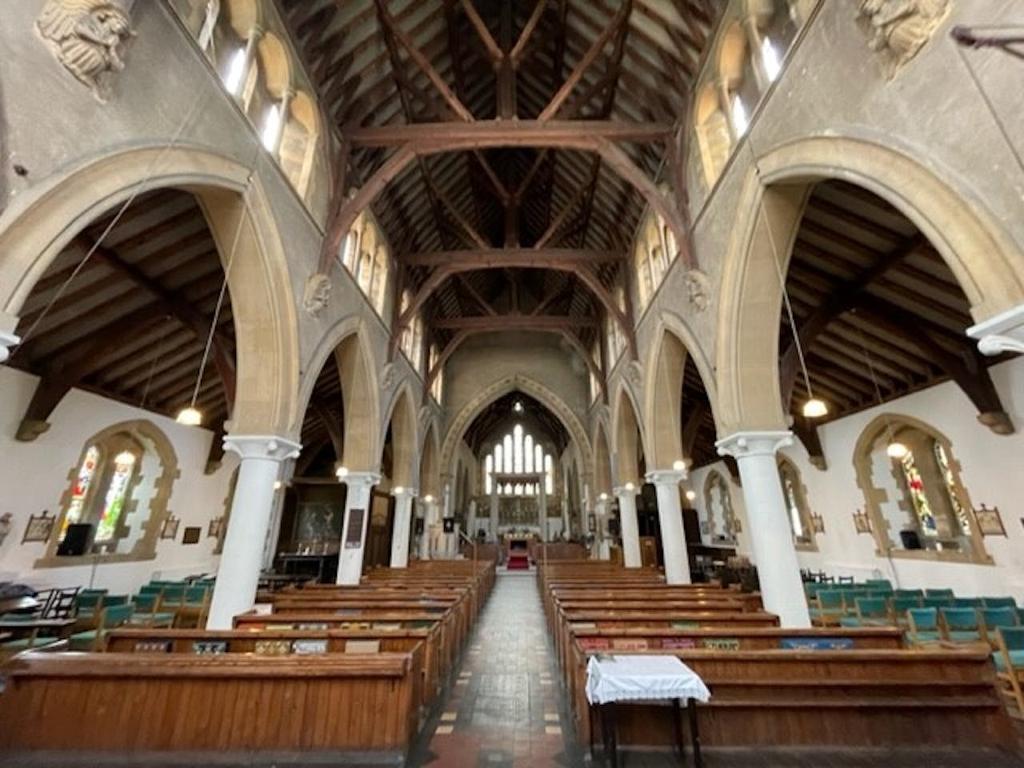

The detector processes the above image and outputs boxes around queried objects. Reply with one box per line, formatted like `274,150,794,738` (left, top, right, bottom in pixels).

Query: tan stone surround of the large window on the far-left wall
34,419,181,568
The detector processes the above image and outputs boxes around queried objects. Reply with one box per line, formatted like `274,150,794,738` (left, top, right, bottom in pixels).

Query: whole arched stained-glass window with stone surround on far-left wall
36,420,177,566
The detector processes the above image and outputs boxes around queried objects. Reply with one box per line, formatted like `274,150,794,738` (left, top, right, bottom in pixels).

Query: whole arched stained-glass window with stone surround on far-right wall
854,415,989,562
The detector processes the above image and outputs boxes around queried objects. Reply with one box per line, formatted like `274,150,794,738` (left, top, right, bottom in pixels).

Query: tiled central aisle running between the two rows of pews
411,572,582,768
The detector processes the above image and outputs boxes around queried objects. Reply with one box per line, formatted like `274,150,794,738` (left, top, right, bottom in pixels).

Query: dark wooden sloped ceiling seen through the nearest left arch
10,189,234,438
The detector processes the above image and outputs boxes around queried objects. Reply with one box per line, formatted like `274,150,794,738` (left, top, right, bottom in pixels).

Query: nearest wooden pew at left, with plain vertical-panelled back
0,652,419,764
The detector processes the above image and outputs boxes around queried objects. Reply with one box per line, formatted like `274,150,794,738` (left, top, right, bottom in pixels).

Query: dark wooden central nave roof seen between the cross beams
279,0,723,358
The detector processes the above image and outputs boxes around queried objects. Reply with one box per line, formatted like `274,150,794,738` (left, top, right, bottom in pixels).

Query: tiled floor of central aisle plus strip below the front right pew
410,572,1024,768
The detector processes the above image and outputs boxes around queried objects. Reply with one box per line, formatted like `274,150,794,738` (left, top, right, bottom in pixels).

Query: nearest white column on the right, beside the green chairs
716,431,811,628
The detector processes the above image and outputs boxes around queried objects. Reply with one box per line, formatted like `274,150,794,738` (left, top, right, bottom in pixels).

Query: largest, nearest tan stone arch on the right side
717,136,1024,435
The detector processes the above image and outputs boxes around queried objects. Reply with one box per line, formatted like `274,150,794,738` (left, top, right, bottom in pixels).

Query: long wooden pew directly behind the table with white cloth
570,646,1015,749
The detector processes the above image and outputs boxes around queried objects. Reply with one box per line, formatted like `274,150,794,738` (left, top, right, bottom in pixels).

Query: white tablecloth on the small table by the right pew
587,655,711,705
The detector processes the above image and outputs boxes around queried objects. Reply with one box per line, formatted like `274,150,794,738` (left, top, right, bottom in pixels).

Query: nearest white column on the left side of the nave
206,435,302,630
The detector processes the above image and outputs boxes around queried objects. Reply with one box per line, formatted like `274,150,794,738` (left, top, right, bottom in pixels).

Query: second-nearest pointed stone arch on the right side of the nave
643,312,718,469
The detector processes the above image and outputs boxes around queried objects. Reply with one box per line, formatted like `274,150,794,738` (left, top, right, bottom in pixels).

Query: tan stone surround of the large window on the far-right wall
851,412,995,565
